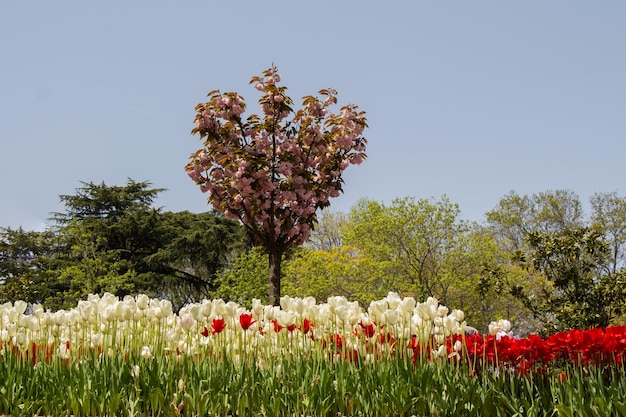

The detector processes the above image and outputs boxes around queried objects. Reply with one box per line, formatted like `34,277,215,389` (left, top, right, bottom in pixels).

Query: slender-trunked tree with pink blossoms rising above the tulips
185,66,367,305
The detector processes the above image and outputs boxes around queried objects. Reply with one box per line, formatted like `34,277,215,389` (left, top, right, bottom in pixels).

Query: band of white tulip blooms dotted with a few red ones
0,293,465,359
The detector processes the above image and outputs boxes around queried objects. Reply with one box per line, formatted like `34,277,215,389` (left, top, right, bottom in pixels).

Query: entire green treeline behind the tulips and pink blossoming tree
0,179,626,334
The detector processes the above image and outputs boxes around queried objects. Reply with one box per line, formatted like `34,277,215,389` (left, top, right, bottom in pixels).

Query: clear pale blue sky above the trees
0,0,626,230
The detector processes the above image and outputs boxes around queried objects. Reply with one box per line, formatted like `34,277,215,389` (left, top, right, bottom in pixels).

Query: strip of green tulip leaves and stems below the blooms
0,355,626,417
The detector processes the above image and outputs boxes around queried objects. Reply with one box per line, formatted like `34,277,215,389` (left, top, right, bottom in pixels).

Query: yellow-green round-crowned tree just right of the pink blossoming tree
344,196,467,303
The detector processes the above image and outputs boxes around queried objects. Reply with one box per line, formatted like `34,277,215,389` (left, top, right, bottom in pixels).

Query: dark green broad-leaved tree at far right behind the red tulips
515,227,625,332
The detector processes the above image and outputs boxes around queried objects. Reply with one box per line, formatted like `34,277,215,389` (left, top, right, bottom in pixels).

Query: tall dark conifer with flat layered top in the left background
52,179,163,299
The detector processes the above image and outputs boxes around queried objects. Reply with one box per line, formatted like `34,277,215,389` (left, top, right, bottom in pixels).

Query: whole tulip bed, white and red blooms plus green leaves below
0,293,626,416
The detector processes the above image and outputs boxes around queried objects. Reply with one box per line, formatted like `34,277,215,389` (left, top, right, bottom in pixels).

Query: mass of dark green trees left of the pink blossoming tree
0,180,250,310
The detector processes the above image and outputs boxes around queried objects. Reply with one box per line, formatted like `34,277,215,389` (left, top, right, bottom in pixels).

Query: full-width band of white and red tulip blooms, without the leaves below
0,293,626,373
